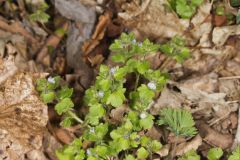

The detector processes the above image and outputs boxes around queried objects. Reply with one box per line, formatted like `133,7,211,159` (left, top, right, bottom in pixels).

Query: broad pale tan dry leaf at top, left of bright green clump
119,0,189,39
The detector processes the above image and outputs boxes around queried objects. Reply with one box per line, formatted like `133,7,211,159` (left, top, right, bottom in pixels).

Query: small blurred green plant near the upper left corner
29,2,50,23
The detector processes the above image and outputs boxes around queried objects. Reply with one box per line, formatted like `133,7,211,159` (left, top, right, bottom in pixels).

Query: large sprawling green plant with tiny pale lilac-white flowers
37,33,191,160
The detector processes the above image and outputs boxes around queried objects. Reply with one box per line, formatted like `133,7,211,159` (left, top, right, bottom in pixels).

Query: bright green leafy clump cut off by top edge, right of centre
168,0,203,19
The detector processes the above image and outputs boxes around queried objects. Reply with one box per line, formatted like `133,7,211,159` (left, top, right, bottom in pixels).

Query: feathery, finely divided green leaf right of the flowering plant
158,108,197,137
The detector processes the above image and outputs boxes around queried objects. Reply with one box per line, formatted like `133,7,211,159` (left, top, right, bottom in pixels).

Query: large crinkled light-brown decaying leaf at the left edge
0,59,48,160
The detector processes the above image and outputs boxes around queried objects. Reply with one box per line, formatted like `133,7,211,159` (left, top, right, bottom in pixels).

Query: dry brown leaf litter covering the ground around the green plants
0,0,240,160
